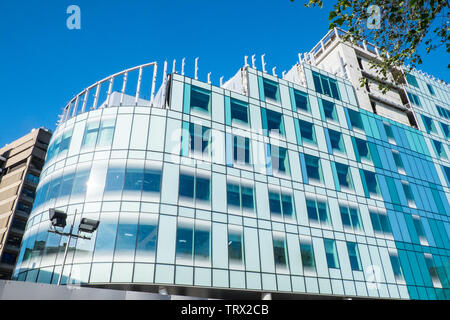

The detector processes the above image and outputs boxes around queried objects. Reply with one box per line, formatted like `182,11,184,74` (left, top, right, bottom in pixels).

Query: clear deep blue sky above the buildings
0,0,448,147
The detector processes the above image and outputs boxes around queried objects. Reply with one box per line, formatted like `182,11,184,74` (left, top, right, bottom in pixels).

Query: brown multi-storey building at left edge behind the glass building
0,128,52,279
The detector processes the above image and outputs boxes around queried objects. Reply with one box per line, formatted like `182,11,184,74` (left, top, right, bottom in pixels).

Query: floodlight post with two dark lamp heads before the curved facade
48,209,100,286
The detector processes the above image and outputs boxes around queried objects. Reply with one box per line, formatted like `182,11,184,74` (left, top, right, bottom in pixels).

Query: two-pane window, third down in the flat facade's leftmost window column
178,174,210,202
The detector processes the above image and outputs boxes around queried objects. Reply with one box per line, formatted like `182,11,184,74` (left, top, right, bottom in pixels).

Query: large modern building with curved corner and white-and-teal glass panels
14,29,450,299
